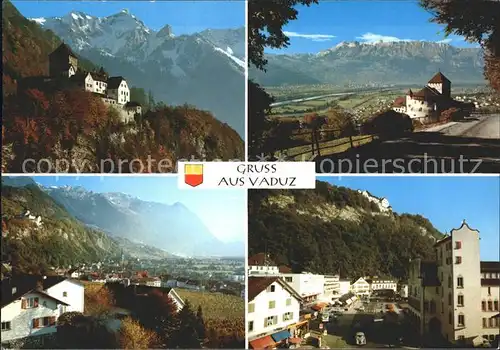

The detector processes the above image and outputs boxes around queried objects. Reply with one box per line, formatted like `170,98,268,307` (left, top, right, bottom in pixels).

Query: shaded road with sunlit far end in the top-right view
316,114,500,173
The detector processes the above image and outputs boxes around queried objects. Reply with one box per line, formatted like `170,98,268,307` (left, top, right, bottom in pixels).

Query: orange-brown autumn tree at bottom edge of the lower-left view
118,317,158,349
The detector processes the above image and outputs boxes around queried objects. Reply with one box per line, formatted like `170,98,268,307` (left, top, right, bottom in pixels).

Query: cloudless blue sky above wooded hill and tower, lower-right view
318,176,500,261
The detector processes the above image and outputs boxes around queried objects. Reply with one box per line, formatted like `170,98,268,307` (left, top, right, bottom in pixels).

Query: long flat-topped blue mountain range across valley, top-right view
249,41,485,86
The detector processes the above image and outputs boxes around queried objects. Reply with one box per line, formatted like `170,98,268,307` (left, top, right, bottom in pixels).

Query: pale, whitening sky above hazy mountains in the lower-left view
33,176,247,242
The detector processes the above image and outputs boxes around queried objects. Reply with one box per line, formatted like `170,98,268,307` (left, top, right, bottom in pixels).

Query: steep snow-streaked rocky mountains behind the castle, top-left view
31,10,246,137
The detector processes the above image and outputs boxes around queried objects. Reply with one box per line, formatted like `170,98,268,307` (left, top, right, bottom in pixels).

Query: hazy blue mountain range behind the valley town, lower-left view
2,177,244,256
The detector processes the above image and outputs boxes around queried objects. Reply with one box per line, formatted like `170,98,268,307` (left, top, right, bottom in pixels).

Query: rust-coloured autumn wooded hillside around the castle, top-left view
2,2,244,173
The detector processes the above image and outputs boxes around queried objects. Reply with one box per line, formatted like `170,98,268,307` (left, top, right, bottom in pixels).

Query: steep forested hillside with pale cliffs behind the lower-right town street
248,181,442,278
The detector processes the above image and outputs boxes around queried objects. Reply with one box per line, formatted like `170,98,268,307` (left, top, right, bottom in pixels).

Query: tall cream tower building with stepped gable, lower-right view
408,220,500,346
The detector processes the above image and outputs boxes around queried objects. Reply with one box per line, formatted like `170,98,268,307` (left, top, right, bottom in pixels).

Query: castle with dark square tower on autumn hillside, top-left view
18,43,142,123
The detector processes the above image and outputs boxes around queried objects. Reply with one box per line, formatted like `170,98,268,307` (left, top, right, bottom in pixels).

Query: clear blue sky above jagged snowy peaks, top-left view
12,0,245,35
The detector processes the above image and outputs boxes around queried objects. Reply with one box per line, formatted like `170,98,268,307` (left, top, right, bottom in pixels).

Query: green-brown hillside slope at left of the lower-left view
2,185,120,273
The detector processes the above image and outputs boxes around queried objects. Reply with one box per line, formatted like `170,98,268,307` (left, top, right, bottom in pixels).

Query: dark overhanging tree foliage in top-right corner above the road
420,0,500,92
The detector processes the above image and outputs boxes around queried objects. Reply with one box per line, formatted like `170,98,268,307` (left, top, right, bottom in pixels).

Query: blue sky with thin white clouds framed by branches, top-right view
266,0,477,53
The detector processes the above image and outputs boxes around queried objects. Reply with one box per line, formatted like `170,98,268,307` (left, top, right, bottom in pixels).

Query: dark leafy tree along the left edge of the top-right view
248,0,318,156
